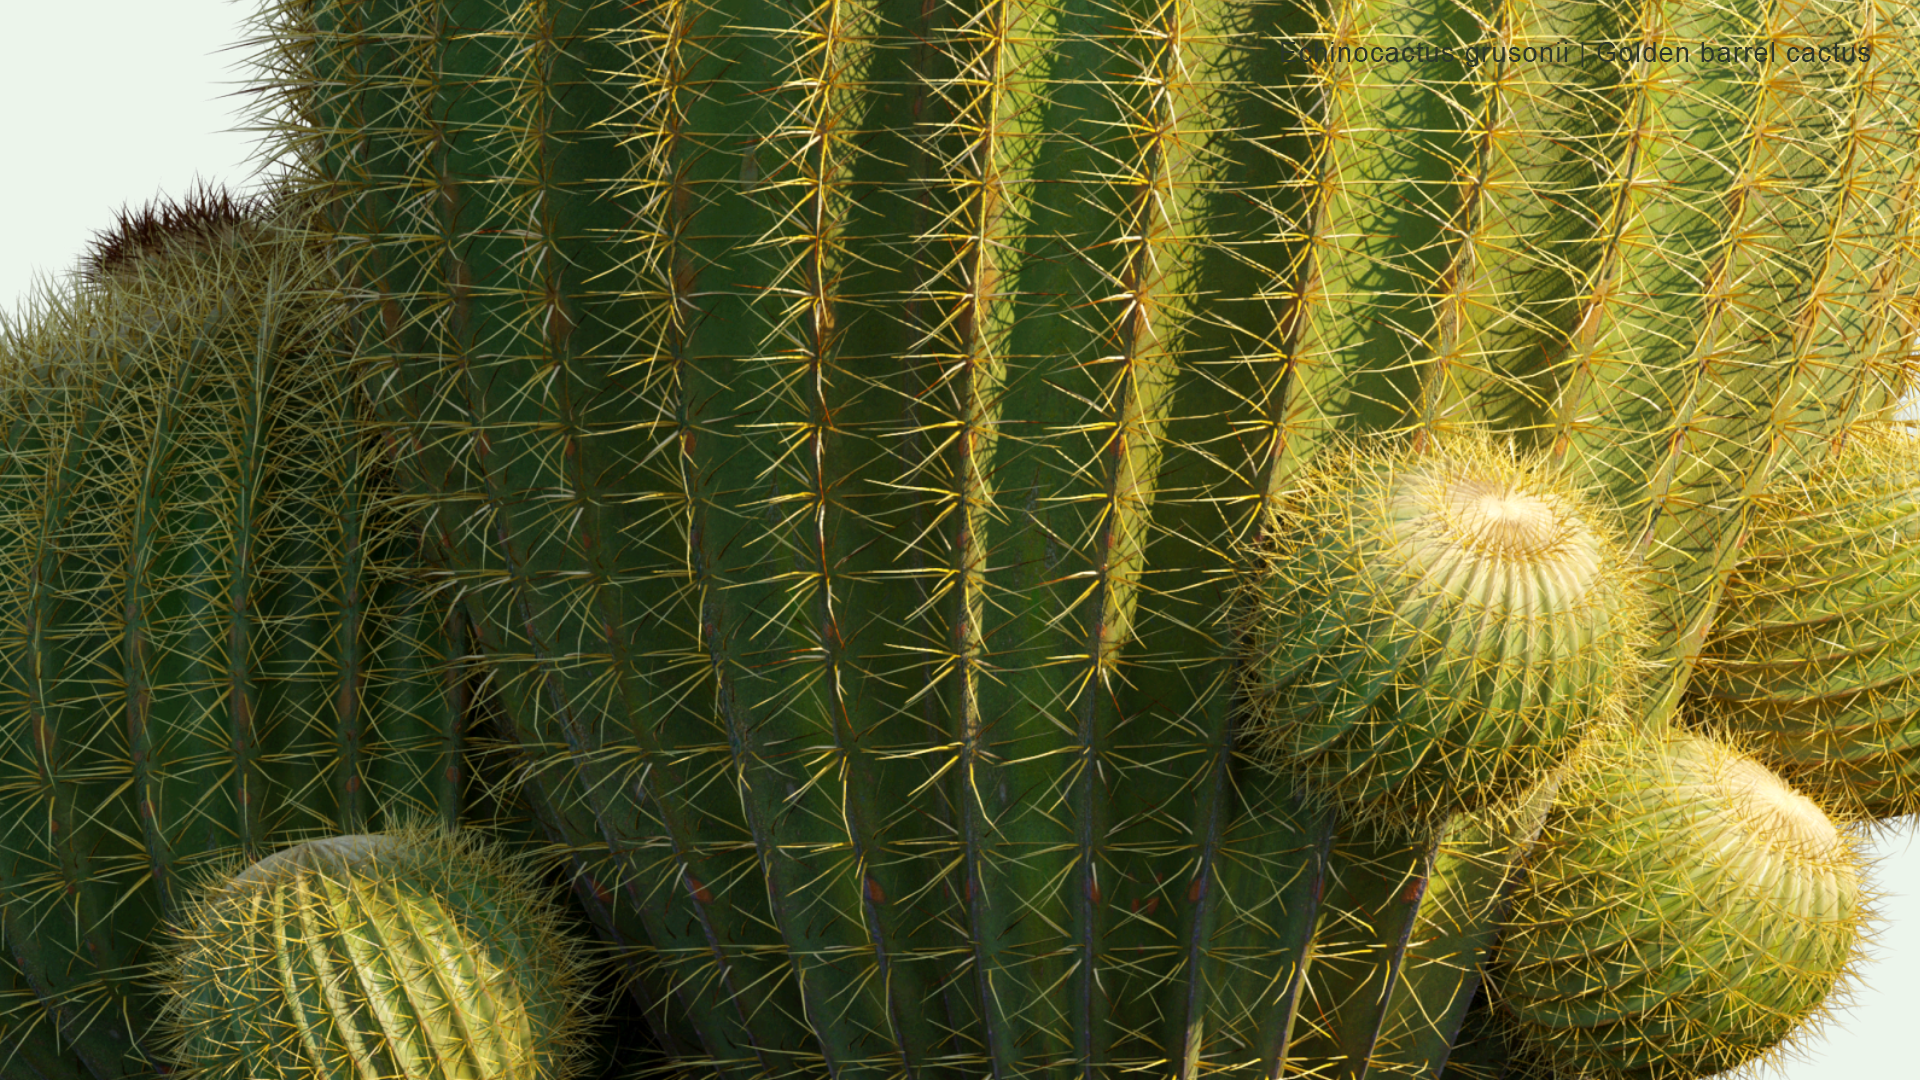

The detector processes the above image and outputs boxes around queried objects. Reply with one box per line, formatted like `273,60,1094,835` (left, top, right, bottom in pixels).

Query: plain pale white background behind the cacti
0,0,1920,1080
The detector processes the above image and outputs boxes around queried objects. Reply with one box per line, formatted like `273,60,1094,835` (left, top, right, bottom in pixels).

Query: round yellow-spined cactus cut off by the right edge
1690,425,1920,819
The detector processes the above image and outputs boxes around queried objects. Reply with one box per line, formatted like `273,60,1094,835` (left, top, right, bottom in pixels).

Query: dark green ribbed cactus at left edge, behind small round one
0,197,463,1080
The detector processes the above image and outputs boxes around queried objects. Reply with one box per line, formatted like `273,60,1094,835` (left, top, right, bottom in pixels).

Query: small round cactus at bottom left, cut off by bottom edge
163,826,586,1080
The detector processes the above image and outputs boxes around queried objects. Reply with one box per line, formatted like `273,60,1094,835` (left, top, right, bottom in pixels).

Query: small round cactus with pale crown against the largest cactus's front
1254,438,1645,821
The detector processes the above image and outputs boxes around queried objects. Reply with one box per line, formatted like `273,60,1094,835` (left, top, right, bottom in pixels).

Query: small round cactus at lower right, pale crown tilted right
1494,728,1868,1080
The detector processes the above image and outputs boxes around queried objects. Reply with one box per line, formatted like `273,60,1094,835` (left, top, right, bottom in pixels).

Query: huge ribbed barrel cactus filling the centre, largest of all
271,0,1920,1080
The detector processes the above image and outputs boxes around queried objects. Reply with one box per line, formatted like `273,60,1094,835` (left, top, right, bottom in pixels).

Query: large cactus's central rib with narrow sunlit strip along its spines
900,0,1058,1080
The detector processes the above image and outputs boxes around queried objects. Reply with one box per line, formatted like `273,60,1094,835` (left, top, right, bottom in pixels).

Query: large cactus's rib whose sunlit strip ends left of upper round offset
998,2,1208,1076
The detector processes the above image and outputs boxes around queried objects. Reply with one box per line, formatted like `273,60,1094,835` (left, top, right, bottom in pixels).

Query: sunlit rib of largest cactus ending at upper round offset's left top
1273,0,1482,457
